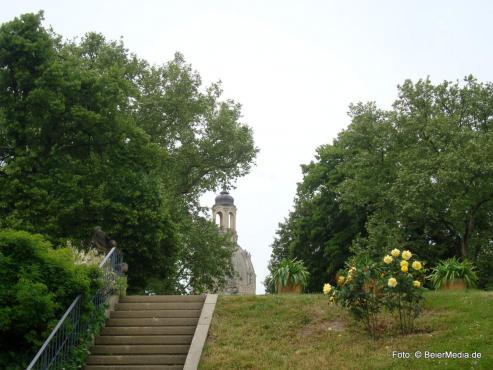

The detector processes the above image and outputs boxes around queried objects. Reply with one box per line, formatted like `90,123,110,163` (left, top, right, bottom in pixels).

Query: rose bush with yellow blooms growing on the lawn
324,249,425,337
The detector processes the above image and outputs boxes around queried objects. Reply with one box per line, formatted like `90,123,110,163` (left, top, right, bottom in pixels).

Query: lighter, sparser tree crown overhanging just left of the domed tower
134,53,258,202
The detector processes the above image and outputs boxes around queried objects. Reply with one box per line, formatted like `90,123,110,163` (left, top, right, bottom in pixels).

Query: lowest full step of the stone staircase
87,355,187,365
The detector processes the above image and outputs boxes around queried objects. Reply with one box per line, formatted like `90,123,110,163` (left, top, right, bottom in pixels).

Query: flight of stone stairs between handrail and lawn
86,295,208,370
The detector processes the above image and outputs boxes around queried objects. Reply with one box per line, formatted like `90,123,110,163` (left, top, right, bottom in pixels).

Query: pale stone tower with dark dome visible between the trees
212,190,256,294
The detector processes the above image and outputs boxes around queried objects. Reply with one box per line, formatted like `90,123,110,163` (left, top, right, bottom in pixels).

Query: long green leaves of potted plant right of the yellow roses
430,257,478,289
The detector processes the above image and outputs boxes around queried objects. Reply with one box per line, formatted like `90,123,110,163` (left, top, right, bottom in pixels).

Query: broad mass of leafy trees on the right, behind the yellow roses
271,77,493,290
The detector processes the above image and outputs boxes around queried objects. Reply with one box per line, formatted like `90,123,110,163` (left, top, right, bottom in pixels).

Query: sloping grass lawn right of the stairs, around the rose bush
199,290,493,370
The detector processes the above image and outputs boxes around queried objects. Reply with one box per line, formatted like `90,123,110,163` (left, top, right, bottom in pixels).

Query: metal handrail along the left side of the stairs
26,247,123,370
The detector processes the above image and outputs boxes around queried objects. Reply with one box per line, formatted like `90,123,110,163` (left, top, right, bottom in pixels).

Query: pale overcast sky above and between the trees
0,0,493,293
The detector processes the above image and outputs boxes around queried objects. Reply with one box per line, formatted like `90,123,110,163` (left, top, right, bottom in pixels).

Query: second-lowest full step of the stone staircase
91,344,190,355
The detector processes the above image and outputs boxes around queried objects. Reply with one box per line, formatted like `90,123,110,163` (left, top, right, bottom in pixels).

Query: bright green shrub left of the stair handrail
0,230,100,369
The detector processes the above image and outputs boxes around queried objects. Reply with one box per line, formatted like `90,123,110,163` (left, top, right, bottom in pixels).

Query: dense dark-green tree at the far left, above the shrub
0,14,177,292
